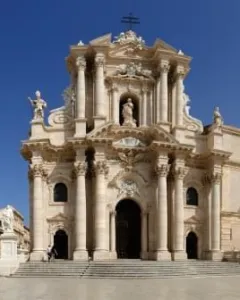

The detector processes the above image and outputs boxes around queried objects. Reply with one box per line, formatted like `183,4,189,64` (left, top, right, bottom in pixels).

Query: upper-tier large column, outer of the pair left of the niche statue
76,56,86,119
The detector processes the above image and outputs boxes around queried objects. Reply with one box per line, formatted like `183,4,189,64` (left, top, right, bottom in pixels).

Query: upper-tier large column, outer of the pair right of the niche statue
176,66,185,126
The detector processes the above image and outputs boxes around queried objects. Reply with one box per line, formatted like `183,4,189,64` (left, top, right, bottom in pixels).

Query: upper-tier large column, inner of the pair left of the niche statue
95,53,105,117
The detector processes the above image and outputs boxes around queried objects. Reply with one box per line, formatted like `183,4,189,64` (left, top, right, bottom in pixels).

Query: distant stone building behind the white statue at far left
0,207,30,251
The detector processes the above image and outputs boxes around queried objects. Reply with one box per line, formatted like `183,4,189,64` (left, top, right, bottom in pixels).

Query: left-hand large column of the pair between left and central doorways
73,161,88,260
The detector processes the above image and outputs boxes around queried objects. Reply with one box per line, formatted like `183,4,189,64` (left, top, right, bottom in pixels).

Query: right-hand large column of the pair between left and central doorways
93,160,109,260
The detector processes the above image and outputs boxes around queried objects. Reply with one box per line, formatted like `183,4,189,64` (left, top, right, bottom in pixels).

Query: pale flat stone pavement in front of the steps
0,276,240,300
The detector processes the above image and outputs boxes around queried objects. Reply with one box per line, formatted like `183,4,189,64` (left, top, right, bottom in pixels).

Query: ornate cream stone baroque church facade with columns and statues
21,31,240,260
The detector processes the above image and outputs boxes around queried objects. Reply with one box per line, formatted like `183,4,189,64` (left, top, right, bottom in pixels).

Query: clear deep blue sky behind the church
0,0,240,223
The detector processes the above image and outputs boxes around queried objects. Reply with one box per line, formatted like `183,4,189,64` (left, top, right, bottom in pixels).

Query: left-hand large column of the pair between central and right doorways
155,162,171,260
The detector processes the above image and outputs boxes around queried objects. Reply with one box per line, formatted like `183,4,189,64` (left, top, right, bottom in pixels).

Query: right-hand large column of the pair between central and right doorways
173,161,188,260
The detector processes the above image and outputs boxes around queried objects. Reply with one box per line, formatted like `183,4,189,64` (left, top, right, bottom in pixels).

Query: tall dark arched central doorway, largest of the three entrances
116,199,141,258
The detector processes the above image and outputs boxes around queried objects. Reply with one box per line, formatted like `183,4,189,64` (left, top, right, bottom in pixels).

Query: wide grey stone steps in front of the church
12,260,240,279
